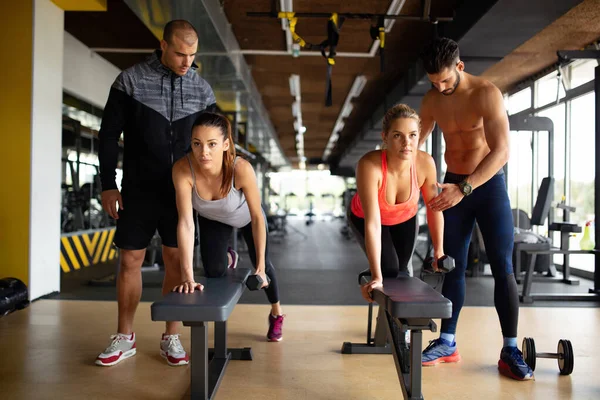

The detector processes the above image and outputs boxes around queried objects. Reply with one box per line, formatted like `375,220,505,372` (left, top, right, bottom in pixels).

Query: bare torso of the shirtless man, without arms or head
428,75,490,174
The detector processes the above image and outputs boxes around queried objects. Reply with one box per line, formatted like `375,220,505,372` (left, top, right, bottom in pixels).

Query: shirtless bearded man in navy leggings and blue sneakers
419,38,533,380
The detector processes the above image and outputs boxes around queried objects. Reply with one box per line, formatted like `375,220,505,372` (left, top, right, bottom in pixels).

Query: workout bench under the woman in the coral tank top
342,271,452,400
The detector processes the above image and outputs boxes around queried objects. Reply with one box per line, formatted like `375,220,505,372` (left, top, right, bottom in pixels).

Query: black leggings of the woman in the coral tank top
348,211,419,278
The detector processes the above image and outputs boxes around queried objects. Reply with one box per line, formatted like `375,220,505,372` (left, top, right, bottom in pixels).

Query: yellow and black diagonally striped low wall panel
60,227,119,273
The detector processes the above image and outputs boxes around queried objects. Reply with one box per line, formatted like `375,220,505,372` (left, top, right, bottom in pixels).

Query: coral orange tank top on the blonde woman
350,151,419,226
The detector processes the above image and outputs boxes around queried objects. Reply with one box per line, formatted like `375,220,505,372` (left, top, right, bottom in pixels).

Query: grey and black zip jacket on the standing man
98,50,216,191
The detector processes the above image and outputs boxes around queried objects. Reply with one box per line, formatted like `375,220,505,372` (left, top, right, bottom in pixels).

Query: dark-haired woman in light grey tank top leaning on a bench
173,113,284,341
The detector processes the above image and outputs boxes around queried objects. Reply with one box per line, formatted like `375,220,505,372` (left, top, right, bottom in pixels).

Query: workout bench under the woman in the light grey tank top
151,268,252,400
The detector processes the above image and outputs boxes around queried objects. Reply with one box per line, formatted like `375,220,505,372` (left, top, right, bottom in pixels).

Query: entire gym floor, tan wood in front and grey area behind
0,221,600,400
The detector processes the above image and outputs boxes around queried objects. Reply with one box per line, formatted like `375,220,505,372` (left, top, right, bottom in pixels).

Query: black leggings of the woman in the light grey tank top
198,215,279,304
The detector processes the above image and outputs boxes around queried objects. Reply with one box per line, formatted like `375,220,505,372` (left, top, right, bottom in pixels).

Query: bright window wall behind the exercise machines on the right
505,60,600,272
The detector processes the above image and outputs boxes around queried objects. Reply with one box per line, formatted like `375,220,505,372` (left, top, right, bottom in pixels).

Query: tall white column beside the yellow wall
29,0,64,300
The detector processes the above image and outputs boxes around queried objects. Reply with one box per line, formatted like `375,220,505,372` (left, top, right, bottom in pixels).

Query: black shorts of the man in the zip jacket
114,188,178,250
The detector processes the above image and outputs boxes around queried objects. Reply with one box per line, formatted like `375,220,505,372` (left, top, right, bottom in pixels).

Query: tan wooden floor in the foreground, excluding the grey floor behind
0,300,600,400
